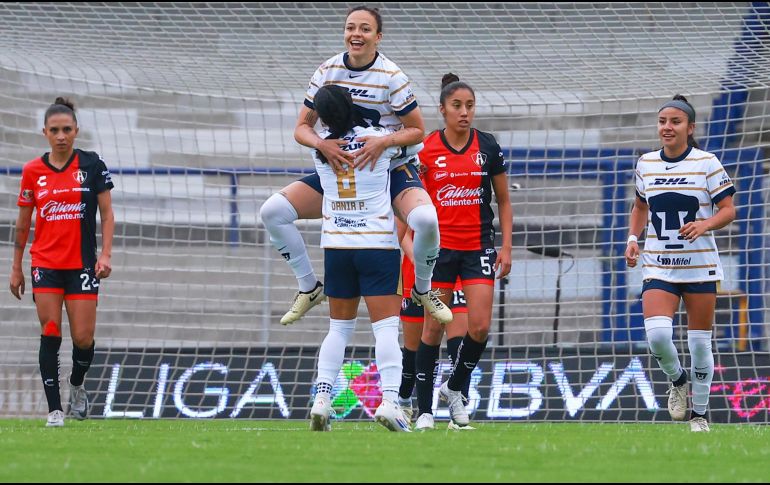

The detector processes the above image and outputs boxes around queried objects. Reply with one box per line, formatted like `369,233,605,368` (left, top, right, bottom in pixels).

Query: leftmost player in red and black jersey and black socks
10,98,115,426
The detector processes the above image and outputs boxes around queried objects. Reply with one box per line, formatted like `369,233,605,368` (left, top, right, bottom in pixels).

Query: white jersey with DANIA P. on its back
313,127,401,249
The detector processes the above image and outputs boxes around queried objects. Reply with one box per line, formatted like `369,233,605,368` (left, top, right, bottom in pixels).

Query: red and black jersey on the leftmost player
18,149,114,269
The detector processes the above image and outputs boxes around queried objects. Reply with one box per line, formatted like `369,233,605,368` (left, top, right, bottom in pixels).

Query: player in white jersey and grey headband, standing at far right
625,95,735,432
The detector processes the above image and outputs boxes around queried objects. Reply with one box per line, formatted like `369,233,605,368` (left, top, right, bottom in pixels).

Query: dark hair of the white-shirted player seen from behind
313,84,367,163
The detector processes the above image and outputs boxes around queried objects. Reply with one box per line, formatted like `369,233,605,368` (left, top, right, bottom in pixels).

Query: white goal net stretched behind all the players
0,2,770,422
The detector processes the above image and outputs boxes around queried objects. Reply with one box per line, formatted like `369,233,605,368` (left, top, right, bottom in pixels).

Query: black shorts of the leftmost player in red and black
32,267,99,300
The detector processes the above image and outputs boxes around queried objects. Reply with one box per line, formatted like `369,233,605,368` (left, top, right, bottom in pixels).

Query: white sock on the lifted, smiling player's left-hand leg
259,194,318,292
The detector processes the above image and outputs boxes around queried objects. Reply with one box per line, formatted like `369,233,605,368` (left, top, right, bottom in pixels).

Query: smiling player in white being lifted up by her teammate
260,6,452,325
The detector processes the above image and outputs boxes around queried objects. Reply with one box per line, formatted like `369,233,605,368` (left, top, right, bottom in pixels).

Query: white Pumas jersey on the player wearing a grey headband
636,148,735,283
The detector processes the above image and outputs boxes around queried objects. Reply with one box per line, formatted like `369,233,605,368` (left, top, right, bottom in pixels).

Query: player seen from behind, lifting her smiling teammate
310,85,411,432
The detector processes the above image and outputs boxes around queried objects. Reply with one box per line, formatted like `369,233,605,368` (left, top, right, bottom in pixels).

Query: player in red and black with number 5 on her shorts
417,74,513,427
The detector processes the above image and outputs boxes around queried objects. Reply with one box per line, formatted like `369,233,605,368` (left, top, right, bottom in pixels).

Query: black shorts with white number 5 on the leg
433,248,497,289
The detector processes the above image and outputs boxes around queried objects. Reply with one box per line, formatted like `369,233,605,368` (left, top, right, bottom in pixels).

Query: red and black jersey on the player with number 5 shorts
420,128,506,251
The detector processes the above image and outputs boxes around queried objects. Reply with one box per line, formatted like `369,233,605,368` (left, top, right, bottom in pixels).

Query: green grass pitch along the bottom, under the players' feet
0,419,770,483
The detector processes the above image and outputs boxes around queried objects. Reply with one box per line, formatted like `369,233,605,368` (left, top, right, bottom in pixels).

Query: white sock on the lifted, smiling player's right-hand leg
406,205,441,293
